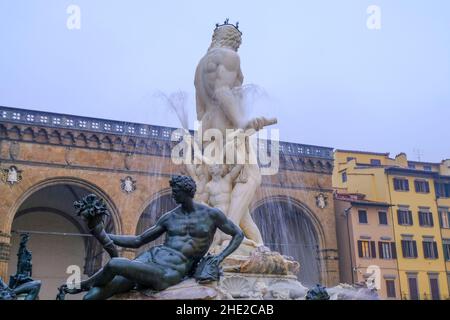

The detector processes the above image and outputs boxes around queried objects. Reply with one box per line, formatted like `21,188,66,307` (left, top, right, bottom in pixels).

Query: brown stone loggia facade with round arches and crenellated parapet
0,107,339,294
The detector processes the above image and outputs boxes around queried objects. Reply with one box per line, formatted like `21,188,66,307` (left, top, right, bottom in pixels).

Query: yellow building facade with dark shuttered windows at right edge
333,150,450,300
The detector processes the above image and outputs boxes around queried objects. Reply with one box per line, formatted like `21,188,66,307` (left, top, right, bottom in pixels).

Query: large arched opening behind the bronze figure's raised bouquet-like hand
8,182,116,300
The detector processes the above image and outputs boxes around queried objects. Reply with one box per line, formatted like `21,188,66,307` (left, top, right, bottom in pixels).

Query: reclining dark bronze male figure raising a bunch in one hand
59,176,244,300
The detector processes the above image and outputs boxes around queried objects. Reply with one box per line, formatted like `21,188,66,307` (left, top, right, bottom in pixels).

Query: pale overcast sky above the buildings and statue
0,0,450,161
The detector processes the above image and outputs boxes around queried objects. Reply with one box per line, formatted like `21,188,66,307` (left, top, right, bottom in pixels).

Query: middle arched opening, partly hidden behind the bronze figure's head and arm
136,193,177,254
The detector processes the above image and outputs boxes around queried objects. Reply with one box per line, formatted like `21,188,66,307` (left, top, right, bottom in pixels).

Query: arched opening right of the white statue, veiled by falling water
253,198,322,286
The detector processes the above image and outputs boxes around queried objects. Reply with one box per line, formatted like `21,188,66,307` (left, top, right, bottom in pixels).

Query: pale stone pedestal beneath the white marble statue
114,247,308,300
